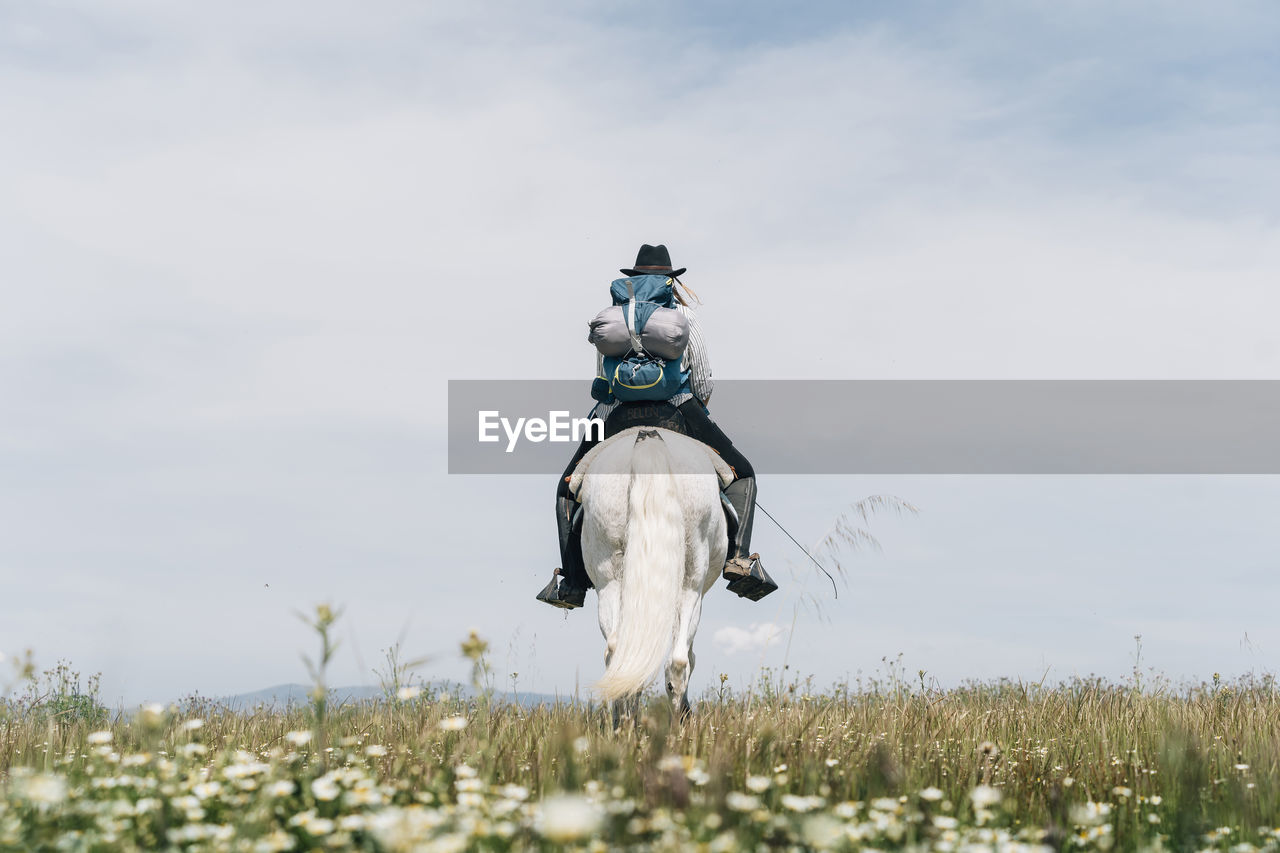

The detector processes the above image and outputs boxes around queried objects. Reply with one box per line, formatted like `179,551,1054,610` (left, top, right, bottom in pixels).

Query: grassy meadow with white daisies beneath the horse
0,610,1280,852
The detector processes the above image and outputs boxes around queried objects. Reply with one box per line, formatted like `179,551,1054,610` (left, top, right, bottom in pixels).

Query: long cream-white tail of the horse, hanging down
595,427,685,702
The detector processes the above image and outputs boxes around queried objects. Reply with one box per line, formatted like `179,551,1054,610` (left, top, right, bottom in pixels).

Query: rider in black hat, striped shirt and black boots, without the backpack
538,243,778,610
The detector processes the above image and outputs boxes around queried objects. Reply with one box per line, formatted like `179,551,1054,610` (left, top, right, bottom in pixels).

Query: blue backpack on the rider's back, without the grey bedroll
591,275,689,403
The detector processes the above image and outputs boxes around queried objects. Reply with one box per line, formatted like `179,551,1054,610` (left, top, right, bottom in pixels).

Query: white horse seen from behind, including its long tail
571,428,732,716
